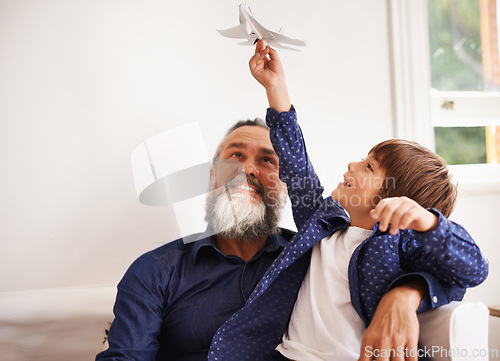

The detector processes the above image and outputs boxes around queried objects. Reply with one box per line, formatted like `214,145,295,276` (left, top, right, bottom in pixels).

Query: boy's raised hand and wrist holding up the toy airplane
249,40,292,113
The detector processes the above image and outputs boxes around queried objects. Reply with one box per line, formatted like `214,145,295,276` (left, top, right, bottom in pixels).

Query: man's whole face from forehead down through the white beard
206,126,286,242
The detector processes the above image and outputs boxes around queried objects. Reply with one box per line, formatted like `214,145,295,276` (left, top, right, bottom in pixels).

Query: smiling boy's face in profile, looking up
332,153,386,220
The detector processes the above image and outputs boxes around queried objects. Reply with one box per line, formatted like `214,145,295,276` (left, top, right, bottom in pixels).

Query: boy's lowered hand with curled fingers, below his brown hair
370,197,438,235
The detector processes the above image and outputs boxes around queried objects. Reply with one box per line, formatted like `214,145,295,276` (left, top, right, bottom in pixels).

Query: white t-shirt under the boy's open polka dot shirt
276,227,372,361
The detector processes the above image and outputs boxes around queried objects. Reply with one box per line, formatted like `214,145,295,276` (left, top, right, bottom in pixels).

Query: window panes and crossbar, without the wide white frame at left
427,0,500,164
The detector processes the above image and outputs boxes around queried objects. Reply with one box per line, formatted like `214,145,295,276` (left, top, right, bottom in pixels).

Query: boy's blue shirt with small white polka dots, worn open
208,107,488,361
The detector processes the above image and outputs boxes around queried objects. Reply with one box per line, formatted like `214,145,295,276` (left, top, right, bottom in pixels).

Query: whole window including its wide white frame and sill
387,0,500,193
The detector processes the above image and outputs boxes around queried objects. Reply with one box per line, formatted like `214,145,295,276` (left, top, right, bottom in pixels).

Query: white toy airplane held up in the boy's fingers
217,4,307,51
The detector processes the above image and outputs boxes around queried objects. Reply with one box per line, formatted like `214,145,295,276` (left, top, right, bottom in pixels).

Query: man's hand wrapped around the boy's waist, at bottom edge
359,281,427,361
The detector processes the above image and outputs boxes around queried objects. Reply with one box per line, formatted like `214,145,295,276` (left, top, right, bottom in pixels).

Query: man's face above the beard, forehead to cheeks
214,126,283,202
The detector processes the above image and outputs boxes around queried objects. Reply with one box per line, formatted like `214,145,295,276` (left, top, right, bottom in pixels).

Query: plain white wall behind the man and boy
0,0,500,354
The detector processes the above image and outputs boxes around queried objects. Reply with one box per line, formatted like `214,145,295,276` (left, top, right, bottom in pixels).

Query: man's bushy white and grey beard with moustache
205,174,286,242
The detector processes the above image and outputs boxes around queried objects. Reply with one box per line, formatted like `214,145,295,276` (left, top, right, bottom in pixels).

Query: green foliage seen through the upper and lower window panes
427,0,486,164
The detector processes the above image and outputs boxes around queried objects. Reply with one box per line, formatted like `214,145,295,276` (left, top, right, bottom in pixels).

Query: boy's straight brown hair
370,139,457,217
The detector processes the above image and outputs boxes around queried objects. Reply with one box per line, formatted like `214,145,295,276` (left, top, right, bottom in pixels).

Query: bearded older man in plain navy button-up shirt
96,120,438,361
